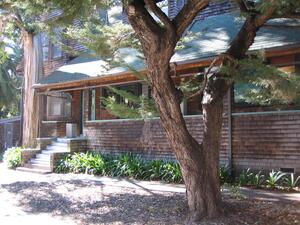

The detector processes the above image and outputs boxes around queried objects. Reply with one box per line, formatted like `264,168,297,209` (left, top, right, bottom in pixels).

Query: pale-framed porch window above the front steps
47,93,72,118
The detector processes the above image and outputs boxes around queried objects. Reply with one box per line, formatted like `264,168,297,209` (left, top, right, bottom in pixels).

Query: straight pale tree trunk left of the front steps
22,31,42,147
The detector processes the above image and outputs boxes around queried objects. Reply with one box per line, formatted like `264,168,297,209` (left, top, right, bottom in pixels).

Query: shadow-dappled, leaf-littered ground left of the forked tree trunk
0,180,186,224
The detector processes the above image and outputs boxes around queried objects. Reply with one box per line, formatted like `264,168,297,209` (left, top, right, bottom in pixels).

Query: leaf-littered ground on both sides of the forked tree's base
0,180,300,225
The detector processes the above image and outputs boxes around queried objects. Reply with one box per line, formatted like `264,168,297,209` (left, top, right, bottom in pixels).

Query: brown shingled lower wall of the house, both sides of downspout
84,111,300,173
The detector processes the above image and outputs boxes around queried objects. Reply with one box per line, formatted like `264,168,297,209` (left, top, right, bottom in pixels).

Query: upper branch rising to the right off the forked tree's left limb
173,0,209,38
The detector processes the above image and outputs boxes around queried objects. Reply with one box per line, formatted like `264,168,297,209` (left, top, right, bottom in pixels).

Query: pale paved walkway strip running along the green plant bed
0,163,300,202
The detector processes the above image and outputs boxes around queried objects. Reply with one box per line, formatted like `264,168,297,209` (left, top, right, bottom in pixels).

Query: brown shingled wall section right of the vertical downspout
232,112,300,173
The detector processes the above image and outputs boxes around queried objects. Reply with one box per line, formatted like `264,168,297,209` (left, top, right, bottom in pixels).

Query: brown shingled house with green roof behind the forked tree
18,0,300,173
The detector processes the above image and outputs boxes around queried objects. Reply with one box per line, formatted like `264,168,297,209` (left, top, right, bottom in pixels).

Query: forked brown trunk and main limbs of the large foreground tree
125,0,274,221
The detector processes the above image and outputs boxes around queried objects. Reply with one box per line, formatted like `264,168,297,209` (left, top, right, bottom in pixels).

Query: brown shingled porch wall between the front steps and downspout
84,116,228,164
